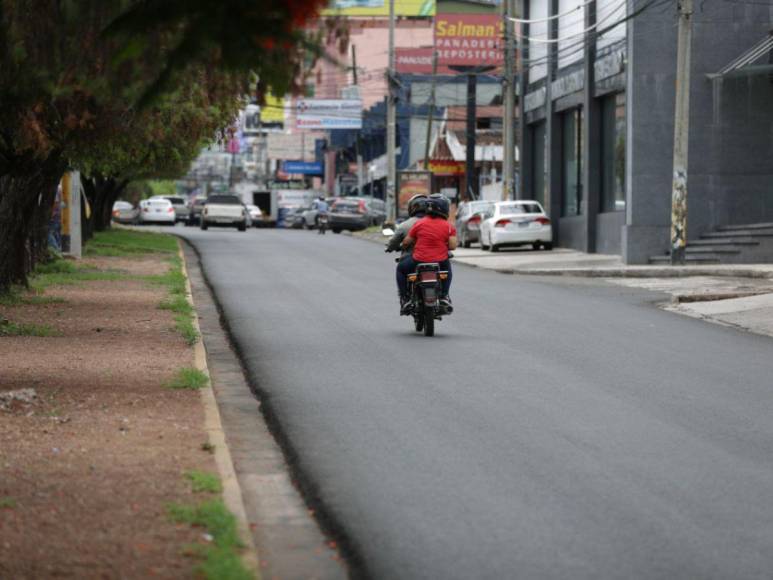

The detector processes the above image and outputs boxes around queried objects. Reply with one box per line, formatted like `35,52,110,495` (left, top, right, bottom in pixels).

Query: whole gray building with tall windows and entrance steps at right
519,0,773,264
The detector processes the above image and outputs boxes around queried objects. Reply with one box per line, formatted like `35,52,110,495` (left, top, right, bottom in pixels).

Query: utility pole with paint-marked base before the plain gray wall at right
671,0,693,264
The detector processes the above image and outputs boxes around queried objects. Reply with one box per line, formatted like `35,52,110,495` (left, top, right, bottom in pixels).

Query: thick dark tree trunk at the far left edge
0,154,65,292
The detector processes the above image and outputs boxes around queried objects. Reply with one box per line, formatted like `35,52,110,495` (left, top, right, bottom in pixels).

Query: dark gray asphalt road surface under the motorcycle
177,228,773,580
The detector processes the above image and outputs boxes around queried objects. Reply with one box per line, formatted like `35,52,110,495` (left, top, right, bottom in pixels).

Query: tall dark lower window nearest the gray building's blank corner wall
601,93,626,212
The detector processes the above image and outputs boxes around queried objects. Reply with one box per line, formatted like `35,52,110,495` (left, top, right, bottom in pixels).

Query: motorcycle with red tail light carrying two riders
382,228,453,336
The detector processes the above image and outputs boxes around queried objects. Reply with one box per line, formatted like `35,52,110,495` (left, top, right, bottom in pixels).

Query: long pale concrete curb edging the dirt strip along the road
177,244,261,579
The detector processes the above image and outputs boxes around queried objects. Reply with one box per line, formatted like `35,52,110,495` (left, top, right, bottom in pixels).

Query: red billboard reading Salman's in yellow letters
435,14,504,67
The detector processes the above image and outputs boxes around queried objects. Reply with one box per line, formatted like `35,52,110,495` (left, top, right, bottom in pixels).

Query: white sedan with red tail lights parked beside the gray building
480,200,553,252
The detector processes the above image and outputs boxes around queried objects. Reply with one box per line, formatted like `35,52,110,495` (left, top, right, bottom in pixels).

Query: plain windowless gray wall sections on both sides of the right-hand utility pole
623,2,773,263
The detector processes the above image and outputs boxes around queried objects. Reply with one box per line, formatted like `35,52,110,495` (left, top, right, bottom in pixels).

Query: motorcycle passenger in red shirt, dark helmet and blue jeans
397,194,456,314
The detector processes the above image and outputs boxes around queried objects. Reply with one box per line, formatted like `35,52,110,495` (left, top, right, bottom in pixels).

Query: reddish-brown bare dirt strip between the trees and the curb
0,256,217,578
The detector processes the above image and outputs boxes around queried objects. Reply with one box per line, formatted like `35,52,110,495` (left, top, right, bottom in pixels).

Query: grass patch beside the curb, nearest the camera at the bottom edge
167,499,253,580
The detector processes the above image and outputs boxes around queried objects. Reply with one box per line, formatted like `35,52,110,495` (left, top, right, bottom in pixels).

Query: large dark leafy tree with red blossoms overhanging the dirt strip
0,0,323,291
